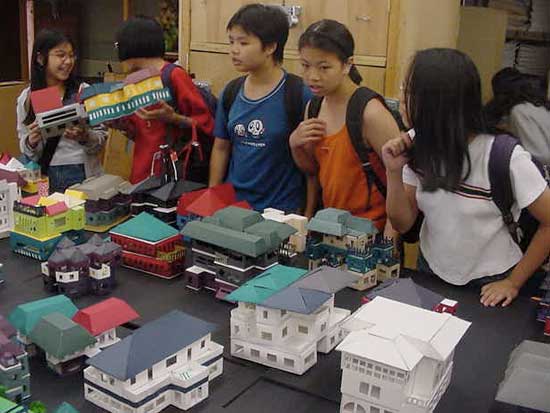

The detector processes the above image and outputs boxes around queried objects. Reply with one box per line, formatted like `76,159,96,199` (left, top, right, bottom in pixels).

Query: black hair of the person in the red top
116,16,165,61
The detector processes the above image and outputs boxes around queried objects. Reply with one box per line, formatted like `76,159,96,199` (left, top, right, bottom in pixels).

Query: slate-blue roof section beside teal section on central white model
261,285,332,314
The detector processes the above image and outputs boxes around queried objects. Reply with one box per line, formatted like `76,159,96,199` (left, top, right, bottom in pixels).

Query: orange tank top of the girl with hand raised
315,126,386,231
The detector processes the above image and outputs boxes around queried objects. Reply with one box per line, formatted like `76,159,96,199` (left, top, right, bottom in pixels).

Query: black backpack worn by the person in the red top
161,63,218,184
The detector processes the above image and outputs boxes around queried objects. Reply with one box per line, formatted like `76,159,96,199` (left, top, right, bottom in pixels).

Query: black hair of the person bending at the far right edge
485,67,550,127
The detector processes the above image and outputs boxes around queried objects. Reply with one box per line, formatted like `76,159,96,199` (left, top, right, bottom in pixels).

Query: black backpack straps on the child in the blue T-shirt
222,73,305,136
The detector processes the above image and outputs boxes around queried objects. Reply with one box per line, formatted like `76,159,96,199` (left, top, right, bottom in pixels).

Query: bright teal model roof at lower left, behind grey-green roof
8,295,78,336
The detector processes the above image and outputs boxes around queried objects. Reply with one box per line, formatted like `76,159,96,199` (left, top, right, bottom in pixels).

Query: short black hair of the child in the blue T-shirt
226,4,289,63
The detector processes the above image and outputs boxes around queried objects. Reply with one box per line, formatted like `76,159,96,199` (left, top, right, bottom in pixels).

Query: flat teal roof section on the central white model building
225,265,307,304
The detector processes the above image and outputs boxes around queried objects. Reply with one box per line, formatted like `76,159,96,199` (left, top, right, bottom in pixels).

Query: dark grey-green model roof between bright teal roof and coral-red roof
29,313,96,359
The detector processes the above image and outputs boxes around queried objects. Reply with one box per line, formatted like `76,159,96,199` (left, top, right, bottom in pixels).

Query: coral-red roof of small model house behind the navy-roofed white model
73,297,139,336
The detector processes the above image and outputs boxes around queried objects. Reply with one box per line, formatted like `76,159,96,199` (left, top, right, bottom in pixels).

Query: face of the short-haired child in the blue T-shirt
228,26,275,72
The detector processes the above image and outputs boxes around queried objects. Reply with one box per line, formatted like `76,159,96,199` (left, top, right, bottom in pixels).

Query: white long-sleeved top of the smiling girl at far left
17,83,107,177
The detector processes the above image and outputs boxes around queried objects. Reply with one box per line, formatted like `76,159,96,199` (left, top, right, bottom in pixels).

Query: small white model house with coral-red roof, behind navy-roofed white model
73,297,139,357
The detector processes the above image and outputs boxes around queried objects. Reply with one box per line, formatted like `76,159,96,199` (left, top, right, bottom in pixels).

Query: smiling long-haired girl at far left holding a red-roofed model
17,30,106,192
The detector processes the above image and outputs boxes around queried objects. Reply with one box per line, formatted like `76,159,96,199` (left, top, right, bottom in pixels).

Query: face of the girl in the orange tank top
300,46,351,96
